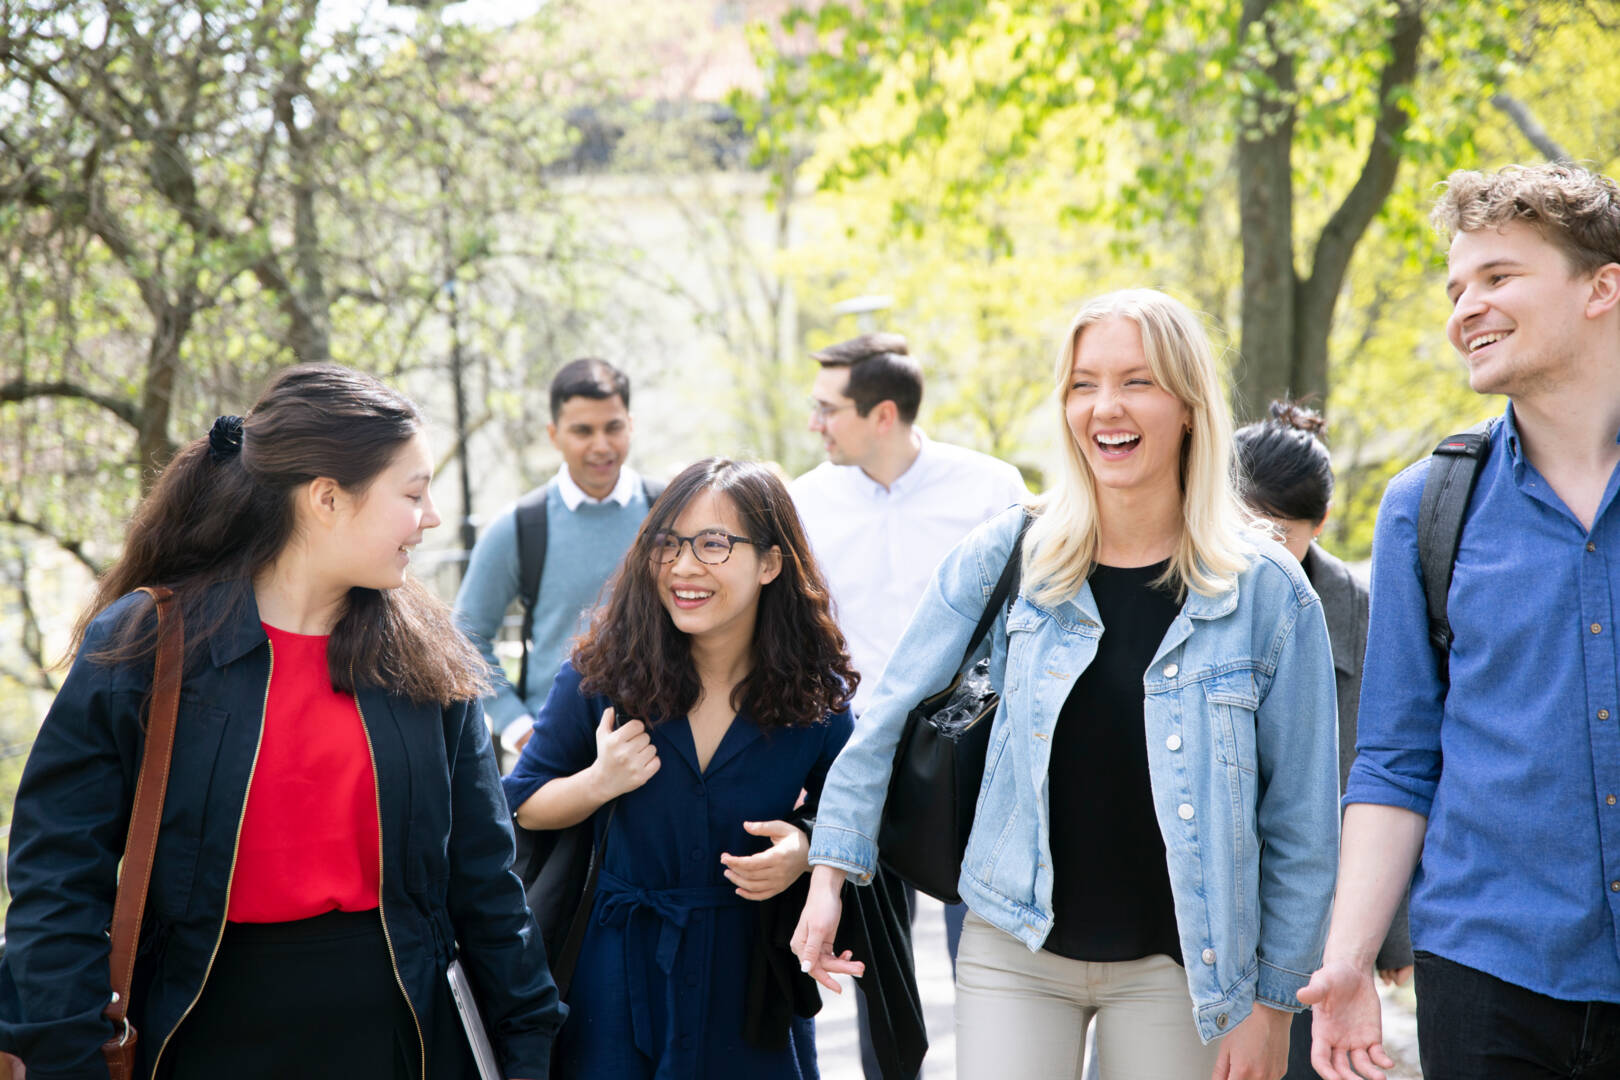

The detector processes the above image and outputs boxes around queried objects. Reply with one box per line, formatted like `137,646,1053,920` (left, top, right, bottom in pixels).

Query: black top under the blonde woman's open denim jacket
1045,560,1181,963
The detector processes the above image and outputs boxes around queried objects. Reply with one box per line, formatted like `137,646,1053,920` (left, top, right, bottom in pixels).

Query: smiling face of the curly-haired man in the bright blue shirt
1445,222,1592,397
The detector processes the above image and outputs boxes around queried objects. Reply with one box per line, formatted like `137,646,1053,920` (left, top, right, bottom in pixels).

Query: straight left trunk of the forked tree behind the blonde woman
1233,0,1296,421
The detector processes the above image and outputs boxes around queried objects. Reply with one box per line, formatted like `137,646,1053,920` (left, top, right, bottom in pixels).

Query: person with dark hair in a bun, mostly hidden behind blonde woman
1234,402,1413,1080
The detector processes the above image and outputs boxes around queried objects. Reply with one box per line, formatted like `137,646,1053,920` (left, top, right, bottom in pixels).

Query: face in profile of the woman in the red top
327,431,441,589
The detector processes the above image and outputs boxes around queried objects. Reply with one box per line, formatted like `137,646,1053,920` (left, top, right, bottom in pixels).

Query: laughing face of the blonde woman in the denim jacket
1063,317,1191,494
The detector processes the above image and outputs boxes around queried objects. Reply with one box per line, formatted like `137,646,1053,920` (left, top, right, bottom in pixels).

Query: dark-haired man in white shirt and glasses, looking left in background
789,334,1029,1080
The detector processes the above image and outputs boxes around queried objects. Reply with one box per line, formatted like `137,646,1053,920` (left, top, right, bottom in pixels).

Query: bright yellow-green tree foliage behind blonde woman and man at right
741,0,1620,557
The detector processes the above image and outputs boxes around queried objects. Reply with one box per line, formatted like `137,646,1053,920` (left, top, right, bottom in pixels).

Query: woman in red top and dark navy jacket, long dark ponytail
0,364,562,1080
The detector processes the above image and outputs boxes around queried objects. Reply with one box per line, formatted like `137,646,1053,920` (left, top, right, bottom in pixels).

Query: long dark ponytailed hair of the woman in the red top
70,364,488,706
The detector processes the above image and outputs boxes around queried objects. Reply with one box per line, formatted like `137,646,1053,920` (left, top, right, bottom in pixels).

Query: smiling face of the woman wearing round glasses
653,487,782,651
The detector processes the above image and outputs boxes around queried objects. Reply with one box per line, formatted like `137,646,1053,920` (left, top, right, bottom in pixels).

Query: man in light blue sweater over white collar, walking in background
455,358,648,753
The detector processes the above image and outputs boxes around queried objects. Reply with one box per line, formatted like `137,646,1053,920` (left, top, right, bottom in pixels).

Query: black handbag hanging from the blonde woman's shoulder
878,513,1030,904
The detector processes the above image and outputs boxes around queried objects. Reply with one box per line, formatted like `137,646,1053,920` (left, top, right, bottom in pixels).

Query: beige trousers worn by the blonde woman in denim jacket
956,912,1218,1080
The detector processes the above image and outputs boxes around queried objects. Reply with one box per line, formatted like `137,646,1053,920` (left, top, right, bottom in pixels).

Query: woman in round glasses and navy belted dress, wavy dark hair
505,458,855,1078
